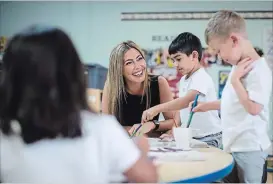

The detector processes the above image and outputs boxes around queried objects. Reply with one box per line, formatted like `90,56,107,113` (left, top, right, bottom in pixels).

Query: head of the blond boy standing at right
205,10,247,65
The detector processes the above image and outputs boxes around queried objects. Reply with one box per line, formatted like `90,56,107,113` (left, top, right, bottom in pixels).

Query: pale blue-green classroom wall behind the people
0,1,273,139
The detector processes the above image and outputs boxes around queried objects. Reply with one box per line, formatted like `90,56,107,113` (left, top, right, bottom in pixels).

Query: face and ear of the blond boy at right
209,34,242,65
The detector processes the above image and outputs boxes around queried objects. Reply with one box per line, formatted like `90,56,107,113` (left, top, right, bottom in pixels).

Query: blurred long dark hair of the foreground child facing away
0,26,89,143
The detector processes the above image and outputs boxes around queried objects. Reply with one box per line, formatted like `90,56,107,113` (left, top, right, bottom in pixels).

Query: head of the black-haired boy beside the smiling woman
169,32,202,75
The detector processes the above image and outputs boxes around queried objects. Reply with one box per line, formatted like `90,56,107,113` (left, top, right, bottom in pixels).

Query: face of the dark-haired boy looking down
171,51,198,75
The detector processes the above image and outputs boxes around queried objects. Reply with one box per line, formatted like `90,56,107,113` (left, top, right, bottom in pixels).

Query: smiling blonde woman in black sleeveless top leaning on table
102,41,179,134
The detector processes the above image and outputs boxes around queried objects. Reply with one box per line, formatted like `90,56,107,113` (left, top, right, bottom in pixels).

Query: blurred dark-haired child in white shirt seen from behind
0,26,157,184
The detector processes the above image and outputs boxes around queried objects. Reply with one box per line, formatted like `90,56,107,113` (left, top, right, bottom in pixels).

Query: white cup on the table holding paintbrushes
173,127,192,149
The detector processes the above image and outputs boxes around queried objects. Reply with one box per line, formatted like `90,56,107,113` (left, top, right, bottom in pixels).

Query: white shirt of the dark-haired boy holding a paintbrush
179,68,221,137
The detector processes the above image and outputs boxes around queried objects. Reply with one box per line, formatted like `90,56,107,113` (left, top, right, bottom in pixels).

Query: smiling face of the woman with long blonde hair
123,48,146,83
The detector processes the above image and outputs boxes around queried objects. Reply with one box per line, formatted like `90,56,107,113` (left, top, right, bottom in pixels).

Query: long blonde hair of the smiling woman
105,41,150,124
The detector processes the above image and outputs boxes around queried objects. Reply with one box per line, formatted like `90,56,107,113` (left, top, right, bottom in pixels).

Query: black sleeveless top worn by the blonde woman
117,76,160,126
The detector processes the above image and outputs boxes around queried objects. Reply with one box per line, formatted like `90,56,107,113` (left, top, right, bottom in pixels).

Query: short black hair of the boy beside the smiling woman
169,32,202,61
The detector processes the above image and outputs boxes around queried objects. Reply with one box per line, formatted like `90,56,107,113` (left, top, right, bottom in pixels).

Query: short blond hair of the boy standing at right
205,10,246,44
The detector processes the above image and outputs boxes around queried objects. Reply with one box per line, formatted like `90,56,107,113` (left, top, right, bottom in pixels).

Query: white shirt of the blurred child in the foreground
0,111,140,184
